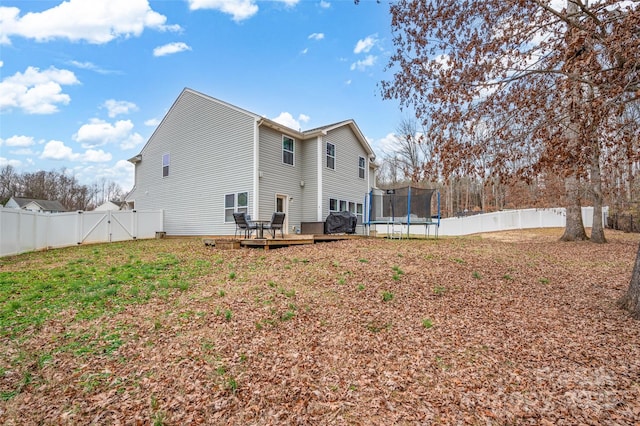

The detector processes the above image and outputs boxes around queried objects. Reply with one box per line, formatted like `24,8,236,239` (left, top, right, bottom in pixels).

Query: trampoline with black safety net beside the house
365,185,440,238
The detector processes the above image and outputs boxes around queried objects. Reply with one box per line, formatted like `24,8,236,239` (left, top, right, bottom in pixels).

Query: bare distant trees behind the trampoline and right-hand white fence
377,114,640,217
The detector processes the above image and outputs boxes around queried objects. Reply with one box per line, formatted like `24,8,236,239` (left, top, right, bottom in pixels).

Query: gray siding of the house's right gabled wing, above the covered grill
322,126,369,220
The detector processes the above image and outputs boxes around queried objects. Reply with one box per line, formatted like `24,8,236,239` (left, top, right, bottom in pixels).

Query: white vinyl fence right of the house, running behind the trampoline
371,207,609,236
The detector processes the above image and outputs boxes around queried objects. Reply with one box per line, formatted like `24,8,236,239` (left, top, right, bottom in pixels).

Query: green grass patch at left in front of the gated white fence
0,243,211,338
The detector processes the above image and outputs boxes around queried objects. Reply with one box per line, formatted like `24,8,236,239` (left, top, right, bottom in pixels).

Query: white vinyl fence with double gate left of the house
0,207,164,257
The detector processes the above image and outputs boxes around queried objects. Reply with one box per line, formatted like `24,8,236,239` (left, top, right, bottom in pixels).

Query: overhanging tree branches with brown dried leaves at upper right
382,0,640,181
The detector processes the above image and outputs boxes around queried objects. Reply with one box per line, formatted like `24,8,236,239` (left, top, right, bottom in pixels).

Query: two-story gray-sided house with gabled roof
127,88,375,235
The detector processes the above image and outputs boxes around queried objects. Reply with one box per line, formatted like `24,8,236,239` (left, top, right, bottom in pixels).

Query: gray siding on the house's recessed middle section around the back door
258,126,306,233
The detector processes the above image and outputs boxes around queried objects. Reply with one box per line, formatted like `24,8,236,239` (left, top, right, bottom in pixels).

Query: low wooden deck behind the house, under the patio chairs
203,234,369,250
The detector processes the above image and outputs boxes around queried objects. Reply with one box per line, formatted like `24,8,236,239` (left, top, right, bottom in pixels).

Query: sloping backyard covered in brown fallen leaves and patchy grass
0,229,640,425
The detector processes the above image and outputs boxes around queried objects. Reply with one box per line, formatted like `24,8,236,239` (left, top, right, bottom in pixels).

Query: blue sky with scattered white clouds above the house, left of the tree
0,0,406,191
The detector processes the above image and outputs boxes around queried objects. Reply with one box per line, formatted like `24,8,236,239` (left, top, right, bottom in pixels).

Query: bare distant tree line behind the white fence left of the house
0,165,126,210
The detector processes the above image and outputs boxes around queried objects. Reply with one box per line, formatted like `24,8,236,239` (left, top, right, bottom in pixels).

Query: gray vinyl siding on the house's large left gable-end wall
128,90,255,235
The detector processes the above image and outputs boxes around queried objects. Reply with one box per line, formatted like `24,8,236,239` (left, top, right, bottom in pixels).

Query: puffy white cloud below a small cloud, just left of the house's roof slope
73,118,143,149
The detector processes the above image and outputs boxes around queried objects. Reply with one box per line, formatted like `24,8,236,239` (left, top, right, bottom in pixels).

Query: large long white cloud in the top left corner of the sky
0,0,180,44
